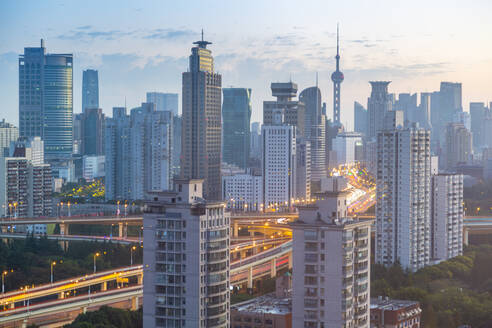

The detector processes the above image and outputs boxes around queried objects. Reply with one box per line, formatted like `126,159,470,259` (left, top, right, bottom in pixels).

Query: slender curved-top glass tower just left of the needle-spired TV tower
299,86,326,181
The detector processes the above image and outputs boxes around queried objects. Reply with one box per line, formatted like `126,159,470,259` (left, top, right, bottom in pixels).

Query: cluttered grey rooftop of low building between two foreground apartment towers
231,294,292,315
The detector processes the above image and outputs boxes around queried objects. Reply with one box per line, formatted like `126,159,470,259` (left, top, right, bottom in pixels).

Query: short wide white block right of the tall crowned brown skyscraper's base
222,173,263,211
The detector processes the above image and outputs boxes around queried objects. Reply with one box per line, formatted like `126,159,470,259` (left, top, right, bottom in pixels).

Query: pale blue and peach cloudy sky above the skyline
0,0,492,130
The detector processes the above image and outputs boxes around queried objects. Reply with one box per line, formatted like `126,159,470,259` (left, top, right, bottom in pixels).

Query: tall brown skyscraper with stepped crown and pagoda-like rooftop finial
181,33,222,200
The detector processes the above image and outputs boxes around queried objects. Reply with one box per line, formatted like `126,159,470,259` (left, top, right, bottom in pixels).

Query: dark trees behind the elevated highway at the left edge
0,236,142,291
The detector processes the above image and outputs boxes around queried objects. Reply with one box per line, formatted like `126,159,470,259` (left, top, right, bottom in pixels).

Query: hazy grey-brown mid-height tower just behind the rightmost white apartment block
443,123,473,172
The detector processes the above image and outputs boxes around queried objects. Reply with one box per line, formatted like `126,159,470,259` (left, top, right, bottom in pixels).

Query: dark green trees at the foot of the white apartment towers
371,244,492,328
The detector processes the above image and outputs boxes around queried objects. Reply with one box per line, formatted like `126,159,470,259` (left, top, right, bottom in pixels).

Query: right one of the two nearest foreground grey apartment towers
291,197,372,328
